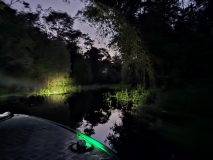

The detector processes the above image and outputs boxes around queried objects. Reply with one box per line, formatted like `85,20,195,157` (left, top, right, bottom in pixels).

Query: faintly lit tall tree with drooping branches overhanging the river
78,1,155,85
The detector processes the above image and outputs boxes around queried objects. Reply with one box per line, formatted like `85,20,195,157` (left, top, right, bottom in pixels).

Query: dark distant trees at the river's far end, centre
71,44,121,85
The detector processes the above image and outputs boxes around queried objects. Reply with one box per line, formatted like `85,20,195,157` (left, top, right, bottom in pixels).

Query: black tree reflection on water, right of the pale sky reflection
107,108,174,160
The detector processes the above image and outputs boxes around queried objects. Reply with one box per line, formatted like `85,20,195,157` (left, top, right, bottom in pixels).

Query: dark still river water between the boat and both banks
0,89,173,159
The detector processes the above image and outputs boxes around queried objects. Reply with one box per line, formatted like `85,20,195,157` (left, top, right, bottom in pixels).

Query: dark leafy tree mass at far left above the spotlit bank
0,2,70,83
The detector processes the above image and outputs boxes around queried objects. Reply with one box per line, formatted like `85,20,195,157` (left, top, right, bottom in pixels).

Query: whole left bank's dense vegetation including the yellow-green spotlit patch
0,1,121,94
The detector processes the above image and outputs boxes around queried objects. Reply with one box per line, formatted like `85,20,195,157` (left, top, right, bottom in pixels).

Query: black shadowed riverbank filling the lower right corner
137,80,213,160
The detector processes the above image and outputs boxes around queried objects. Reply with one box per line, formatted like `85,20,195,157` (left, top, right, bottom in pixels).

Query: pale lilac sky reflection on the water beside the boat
77,109,122,147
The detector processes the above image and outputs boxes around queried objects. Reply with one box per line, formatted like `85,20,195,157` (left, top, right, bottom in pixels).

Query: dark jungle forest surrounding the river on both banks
0,0,213,160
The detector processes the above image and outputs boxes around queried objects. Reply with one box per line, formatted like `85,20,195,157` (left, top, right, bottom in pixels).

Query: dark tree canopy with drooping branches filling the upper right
78,0,213,88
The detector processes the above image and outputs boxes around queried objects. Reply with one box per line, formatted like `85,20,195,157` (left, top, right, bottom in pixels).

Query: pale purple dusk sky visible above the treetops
4,0,113,55
